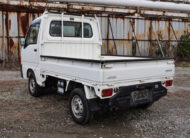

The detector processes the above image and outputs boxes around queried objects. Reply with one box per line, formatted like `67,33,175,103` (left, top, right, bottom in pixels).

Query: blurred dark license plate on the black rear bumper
131,90,149,102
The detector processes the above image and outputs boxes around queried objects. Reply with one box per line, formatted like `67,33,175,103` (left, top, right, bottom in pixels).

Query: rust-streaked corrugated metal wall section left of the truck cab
0,11,40,62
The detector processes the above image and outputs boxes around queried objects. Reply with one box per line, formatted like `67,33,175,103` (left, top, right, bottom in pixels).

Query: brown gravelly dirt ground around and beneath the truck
0,67,190,138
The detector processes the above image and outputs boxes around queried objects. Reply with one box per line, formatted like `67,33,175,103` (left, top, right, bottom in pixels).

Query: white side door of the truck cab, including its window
21,21,40,70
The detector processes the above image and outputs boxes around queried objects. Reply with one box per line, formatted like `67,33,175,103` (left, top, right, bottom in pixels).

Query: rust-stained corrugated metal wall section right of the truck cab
99,17,190,56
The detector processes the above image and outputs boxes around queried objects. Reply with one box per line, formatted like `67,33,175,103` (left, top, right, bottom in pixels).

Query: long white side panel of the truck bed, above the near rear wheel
39,56,102,85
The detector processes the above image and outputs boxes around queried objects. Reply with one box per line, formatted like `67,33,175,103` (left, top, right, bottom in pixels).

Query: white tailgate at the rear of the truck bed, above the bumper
102,59,175,84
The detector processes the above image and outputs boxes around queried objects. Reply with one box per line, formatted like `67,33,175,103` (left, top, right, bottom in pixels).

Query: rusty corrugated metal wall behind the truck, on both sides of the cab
0,0,190,62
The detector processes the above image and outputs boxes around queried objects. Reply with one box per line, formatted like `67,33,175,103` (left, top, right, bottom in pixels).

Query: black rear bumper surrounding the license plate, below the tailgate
109,83,167,108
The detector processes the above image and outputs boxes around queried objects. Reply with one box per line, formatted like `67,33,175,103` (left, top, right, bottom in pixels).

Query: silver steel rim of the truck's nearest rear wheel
71,95,84,118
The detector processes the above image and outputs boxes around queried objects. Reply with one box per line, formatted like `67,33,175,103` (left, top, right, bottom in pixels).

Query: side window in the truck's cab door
26,23,40,47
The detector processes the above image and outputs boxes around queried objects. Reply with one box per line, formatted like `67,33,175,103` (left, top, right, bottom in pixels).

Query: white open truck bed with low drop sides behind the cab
40,56,174,88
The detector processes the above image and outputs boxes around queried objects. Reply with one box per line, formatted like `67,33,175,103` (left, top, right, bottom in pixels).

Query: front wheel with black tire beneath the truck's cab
28,72,42,97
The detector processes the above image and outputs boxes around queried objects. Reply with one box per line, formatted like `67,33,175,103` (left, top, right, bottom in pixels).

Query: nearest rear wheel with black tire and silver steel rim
69,88,93,125
